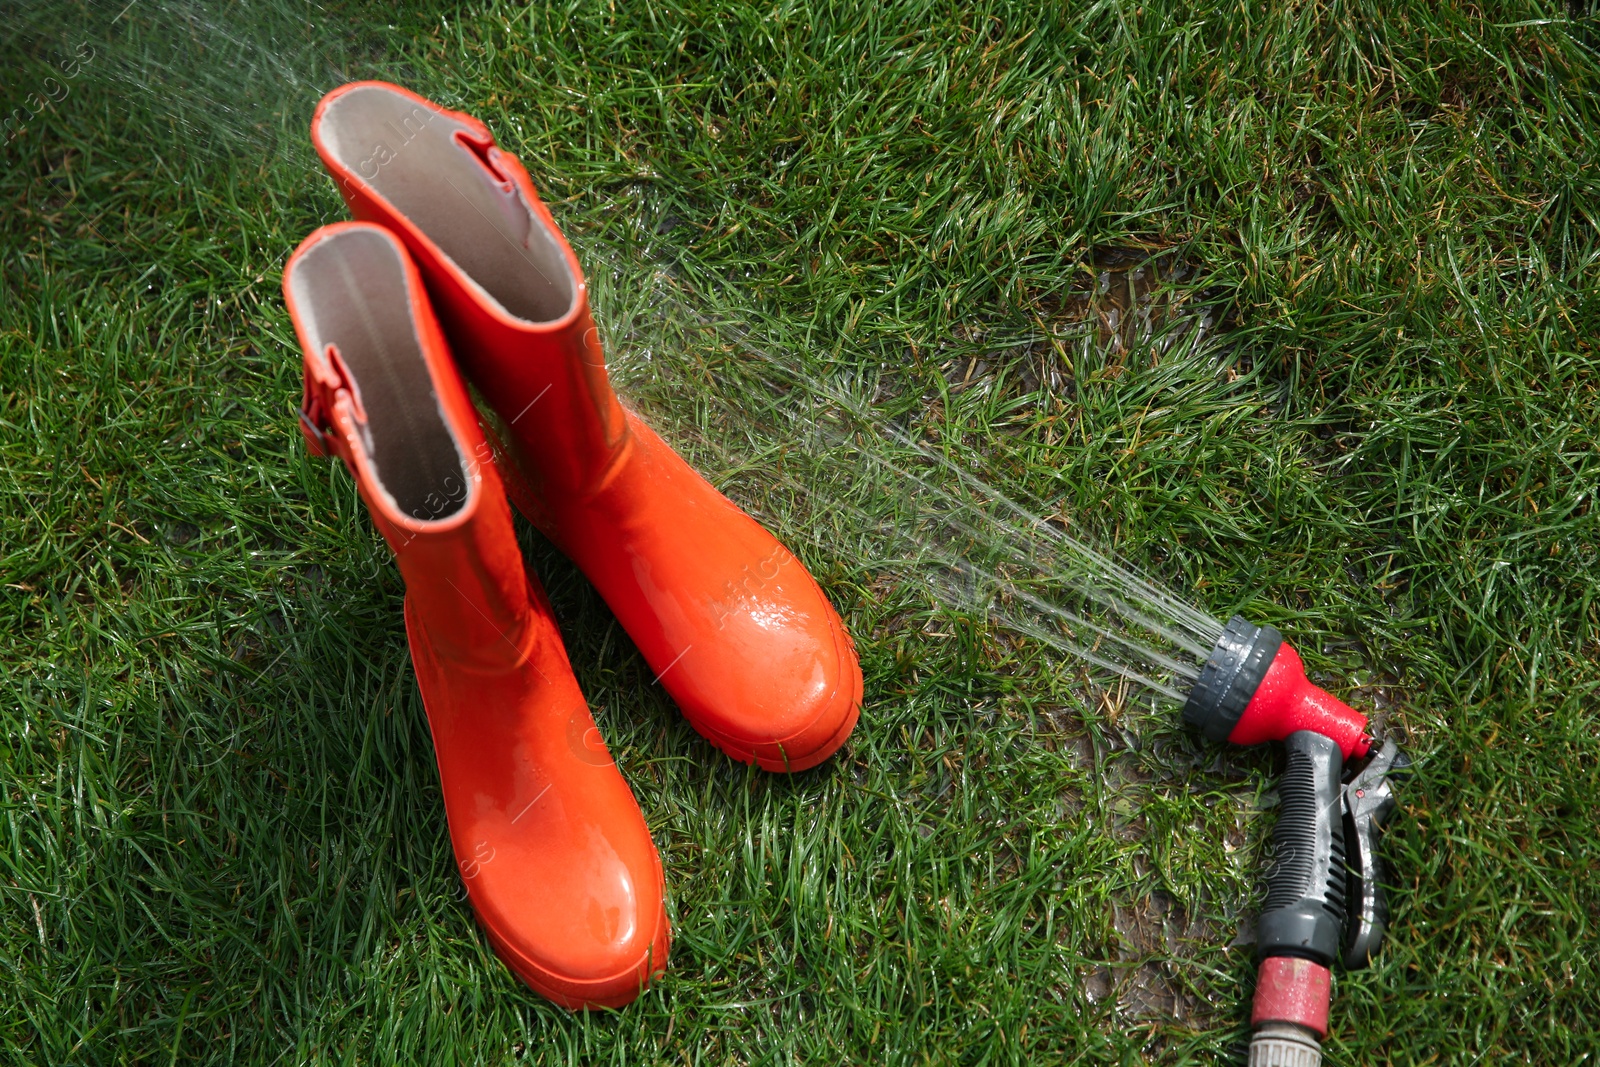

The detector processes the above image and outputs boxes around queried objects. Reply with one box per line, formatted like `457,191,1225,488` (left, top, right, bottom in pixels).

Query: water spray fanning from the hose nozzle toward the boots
584,245,1222,701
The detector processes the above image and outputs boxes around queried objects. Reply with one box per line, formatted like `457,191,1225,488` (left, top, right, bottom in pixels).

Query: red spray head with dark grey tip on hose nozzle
1184,616,1373,760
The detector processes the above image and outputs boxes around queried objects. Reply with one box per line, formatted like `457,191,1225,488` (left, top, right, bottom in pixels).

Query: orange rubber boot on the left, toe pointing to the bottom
283,222,667,1008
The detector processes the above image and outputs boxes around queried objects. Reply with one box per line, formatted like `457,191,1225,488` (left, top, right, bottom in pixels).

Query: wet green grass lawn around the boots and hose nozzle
0,0,1600,1065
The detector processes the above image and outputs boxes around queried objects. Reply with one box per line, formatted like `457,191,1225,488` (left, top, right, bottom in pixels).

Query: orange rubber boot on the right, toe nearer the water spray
312,82,861,771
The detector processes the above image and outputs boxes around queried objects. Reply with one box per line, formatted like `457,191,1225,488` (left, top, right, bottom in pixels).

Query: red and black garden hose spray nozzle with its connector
1184,616,1408,1067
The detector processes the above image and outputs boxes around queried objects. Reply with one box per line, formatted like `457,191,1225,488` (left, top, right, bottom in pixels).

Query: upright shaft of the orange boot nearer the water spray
312,82,629,496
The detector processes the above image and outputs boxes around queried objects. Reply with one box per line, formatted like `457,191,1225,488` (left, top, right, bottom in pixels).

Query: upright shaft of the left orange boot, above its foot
283,222,530,669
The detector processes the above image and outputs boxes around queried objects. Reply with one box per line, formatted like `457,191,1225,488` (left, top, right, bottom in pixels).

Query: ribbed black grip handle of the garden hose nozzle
1256,729,1346,966
